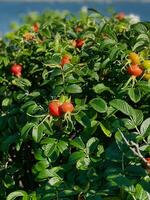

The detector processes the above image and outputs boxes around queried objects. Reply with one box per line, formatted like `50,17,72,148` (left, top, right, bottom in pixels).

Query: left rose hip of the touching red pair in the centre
48,100,61,117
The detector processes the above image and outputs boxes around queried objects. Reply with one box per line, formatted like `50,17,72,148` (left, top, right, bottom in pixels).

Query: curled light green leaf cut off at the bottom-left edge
6,190,29,200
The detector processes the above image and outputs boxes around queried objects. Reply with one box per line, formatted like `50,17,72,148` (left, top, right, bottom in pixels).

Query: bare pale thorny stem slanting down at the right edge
118,128,147,164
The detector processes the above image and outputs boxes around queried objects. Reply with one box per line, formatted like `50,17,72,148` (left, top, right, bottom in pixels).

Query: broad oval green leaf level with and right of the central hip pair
90,98,107,113
